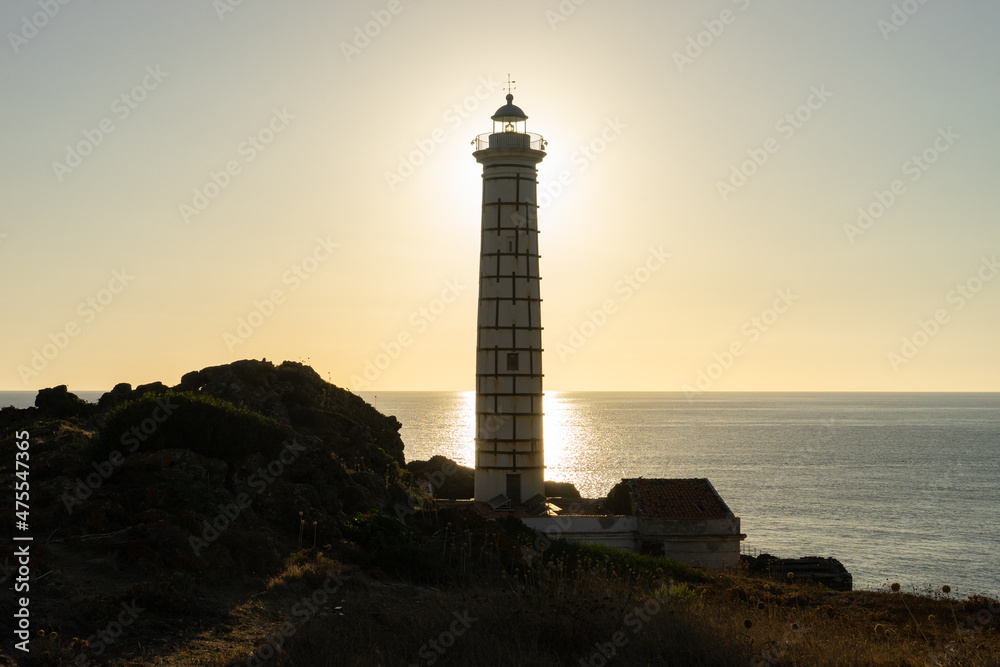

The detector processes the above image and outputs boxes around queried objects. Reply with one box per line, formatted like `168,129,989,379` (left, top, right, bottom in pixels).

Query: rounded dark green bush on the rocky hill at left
92,392,290,460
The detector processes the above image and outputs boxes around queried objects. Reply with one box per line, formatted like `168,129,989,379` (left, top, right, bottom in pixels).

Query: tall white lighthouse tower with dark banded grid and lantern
472,86,545,508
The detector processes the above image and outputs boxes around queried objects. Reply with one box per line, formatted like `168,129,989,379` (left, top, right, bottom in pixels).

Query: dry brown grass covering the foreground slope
133,544,1000,667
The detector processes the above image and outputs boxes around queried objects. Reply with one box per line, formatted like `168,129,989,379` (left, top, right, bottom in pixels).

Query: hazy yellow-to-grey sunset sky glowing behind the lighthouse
0,0,1000,397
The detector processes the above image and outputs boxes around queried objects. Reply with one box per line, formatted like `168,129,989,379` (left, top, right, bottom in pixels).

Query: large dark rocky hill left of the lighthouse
12,360,412,573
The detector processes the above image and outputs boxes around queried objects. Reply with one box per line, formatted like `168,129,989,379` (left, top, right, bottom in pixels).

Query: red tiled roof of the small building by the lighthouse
622,478,734,519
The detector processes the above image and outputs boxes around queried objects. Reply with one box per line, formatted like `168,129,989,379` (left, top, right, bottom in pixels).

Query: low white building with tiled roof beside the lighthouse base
519,478,746,569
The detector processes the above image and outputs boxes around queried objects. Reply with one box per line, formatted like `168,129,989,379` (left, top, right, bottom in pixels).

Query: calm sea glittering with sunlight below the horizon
0,391,1000,599
